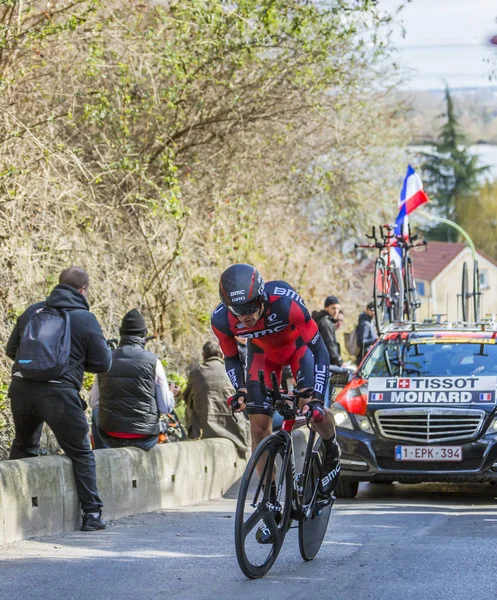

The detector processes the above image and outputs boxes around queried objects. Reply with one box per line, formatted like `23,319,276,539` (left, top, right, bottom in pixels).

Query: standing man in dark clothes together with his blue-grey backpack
6,267,112,531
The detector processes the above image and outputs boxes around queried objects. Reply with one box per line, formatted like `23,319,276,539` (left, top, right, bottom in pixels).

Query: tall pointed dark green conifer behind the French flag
422,87,489,241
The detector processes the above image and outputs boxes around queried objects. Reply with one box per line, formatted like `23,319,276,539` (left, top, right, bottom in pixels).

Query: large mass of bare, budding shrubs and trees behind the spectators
0,0,406,454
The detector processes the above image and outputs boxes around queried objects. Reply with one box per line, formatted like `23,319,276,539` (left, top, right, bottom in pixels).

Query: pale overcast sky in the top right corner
380,0,497,89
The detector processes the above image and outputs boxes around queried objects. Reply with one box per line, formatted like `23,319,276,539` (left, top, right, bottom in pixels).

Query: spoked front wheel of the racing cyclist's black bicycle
235,434,293,579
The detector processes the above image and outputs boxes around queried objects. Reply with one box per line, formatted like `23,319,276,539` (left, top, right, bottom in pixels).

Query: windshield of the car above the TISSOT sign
361,340,497,379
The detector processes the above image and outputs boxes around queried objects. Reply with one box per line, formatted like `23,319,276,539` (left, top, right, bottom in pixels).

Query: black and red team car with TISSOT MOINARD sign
331,322,497,498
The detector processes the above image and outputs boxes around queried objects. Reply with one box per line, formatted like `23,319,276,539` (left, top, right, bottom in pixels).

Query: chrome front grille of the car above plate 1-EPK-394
375,408,486,444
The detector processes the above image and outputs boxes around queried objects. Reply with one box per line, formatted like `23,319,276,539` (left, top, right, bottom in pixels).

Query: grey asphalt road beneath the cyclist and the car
0,484,497,600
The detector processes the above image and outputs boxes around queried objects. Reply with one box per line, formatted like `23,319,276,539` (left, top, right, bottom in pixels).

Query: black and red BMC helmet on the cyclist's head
219,264,267,317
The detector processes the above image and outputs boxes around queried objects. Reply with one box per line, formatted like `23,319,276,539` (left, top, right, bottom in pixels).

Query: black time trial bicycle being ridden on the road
235,367,350,579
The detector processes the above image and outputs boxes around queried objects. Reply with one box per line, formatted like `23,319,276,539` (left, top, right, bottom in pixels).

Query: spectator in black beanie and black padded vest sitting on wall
90,308,179,450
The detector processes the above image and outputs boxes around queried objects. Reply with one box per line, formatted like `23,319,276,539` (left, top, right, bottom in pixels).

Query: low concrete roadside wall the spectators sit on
0,438,246,545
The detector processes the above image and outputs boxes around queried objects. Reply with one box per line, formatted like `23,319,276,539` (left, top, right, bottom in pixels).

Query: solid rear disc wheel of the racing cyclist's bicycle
299,440,333,561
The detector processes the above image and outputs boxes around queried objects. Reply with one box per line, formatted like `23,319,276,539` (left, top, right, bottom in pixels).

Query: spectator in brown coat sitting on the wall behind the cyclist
184,341,250,454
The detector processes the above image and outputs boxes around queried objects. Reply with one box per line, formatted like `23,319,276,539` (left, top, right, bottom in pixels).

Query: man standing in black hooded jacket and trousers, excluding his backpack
6,267,111,531
